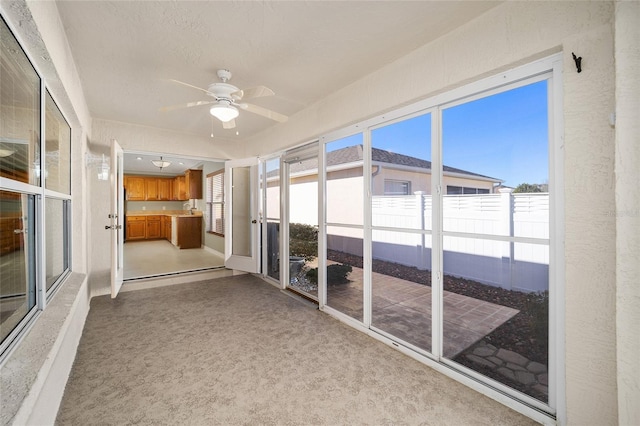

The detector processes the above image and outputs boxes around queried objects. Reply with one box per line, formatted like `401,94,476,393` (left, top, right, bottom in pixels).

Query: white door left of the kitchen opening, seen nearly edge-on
109,139,125,298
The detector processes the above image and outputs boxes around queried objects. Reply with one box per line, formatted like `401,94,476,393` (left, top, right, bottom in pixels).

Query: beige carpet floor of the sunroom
57,275,534,425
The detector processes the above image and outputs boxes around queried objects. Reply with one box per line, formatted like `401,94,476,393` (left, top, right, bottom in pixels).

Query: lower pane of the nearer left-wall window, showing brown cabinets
0,191,36,341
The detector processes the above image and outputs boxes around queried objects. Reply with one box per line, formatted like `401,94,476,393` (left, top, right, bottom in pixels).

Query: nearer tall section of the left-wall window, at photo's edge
0,15,44,354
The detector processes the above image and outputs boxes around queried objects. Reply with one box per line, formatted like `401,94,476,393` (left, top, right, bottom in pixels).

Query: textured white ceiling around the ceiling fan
57,0,498,138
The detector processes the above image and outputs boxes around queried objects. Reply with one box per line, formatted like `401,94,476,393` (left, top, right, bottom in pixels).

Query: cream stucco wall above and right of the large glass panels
248,1,624,424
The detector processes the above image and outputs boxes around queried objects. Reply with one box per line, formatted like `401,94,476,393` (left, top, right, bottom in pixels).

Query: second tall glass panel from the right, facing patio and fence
371,113,432,352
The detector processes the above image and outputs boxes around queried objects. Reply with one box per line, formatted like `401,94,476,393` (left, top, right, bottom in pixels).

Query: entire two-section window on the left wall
0,15,71,358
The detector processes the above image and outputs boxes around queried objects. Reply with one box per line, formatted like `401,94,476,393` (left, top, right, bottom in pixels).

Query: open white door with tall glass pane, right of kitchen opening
224,158,260,273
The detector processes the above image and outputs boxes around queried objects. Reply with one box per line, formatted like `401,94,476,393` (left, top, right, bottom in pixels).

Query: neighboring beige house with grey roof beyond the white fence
267,145,503,225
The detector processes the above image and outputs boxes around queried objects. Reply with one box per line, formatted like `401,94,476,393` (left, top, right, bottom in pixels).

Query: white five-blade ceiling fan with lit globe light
160,70,288,129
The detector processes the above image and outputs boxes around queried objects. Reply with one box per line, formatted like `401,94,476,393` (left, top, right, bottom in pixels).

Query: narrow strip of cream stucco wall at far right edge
615,1,640,425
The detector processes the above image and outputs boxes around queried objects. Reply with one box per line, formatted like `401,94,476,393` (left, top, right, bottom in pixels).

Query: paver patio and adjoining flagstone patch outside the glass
288,267,549,395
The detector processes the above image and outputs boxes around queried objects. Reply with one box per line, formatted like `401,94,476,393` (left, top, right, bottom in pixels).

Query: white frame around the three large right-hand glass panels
318,53,566,423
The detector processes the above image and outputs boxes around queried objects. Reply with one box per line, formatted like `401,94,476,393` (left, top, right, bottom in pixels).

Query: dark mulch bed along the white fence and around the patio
327,250,548,368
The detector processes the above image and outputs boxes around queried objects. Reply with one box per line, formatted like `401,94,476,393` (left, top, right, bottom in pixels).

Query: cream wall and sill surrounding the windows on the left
0,0,91,424
